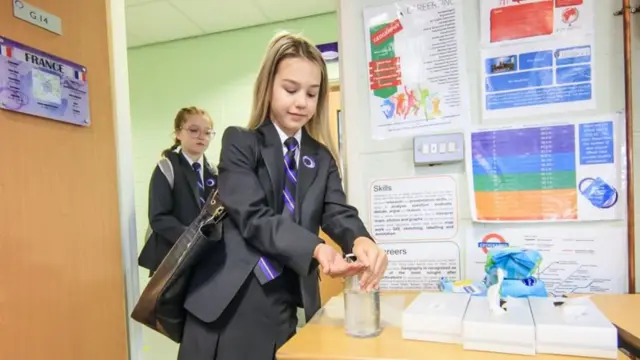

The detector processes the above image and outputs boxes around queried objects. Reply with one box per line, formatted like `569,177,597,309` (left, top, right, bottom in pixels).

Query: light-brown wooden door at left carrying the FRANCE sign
0,0,128,360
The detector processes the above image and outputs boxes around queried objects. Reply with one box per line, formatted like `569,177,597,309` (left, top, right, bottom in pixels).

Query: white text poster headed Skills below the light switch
369,175,459,242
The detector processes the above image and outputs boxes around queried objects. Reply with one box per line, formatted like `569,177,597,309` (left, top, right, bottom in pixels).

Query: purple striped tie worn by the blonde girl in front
254,137,298,284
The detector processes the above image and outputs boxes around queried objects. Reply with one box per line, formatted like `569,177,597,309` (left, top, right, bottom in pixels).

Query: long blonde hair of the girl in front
248,32,339,162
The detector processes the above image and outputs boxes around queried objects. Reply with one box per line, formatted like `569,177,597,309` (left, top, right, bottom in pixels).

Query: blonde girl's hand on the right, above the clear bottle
353,237,389,291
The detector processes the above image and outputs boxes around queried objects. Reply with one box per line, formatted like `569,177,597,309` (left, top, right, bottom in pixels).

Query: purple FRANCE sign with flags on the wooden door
0,36,91,126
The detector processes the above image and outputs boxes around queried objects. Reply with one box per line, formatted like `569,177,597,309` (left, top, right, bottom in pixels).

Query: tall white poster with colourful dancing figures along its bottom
364,0,470,139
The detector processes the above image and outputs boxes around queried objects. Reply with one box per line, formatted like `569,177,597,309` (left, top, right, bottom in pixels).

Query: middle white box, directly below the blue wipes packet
462,296,536,355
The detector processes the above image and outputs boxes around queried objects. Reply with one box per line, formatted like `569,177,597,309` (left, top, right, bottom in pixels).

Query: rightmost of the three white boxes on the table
529,297,618,359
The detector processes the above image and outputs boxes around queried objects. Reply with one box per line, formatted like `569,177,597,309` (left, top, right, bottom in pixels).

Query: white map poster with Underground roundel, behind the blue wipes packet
465,225,627,296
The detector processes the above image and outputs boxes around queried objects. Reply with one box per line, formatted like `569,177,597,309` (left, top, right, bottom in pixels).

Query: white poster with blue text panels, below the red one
481,38,596,119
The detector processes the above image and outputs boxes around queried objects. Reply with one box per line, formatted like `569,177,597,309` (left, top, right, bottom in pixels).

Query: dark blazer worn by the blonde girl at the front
185,121,370,322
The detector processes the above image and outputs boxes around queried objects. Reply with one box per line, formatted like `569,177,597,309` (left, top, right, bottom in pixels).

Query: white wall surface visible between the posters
338,0,640,292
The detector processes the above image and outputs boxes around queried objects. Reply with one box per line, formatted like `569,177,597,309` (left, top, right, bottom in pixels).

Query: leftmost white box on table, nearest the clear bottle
402,292,470,344
